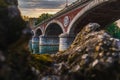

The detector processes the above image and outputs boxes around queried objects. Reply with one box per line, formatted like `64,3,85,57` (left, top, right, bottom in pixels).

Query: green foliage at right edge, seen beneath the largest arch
106,23,120,39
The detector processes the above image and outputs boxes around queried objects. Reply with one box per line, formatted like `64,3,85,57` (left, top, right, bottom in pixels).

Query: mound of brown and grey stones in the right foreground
39,23,120,80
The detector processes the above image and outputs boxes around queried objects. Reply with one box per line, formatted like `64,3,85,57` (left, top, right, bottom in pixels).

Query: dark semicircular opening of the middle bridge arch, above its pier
45,23,63,37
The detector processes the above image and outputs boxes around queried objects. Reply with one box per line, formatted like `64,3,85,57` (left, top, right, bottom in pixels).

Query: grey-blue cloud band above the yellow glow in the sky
19,0,65,9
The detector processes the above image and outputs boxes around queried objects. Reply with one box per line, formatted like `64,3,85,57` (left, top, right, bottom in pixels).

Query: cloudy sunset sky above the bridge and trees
18,0,76,17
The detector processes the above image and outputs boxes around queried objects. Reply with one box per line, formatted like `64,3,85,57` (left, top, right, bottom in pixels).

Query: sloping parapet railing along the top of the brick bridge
35,0,93,28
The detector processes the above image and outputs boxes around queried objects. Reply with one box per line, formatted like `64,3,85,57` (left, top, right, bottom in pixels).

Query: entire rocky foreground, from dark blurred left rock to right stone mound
0,0,120,80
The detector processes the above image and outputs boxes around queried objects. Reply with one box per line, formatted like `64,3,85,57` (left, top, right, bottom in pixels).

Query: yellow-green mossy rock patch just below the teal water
30,54,53,71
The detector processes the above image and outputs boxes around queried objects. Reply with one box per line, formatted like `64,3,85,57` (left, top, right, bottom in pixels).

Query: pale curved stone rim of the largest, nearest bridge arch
67,0,115,34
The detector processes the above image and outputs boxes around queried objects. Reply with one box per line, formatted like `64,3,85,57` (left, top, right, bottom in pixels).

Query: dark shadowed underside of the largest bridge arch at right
70,1,120,35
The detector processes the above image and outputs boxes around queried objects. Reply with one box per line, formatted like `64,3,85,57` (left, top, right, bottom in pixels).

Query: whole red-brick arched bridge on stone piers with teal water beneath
32,0,120,53
